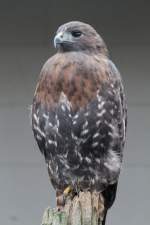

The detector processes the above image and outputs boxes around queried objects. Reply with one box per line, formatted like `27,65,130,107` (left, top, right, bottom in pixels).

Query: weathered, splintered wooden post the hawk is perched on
42,192,104,225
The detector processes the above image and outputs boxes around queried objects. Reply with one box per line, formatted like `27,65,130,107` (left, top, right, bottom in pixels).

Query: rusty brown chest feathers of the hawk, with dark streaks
35,53,109,110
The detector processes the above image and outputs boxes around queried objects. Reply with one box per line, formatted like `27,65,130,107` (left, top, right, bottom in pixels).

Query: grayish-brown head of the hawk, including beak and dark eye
54,21,107,55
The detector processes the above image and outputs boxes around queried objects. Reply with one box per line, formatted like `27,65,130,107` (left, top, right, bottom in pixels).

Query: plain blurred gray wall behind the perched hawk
0,0,150,225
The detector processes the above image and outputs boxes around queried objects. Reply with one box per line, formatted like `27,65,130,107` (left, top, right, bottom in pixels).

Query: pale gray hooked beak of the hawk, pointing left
54,32,73,48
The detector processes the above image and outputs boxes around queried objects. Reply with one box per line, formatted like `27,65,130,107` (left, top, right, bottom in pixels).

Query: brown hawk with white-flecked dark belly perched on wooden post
32,21,127,225
